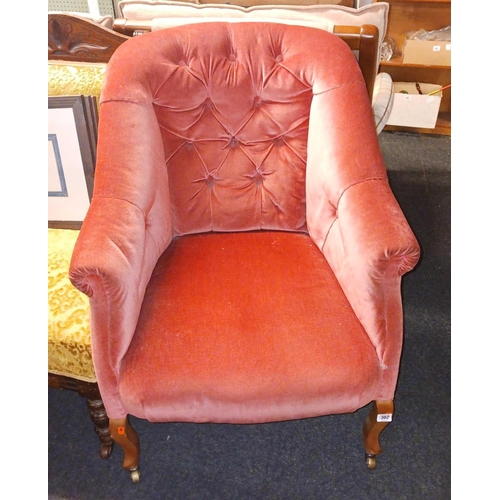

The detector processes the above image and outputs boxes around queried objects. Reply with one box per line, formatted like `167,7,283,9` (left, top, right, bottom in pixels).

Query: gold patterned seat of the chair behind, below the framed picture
48,229,96,382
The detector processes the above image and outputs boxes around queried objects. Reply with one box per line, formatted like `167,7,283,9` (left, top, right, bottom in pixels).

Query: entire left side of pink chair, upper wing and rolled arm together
70,101,172,418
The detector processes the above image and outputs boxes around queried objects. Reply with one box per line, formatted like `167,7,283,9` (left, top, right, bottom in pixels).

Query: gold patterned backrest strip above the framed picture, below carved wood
48,61,106,108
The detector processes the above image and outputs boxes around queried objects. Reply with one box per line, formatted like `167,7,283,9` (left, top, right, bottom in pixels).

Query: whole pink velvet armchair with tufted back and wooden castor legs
70,23,419,481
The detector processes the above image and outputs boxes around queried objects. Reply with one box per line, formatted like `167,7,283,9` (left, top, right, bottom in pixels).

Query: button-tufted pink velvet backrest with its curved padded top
96,23,373,235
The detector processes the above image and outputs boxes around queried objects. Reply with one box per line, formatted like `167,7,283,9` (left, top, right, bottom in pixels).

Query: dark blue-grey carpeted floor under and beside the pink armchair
48,132,451,500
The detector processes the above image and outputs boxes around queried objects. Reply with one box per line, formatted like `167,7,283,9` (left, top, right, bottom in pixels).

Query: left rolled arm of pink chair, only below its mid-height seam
69,198,164,418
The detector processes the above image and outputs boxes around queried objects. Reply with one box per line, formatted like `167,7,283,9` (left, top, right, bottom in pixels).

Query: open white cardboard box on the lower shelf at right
387,82,443,128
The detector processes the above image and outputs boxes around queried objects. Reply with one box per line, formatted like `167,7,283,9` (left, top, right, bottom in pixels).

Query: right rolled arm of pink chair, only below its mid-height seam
322,179,420,400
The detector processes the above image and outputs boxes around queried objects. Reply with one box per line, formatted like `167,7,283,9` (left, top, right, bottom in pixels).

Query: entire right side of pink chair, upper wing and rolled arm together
306,78,420,400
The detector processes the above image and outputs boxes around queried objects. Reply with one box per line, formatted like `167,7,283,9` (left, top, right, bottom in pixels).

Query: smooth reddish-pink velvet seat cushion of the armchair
120,231,380,423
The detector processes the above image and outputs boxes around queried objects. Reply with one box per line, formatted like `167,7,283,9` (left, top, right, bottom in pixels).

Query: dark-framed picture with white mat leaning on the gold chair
48,96,97,229
